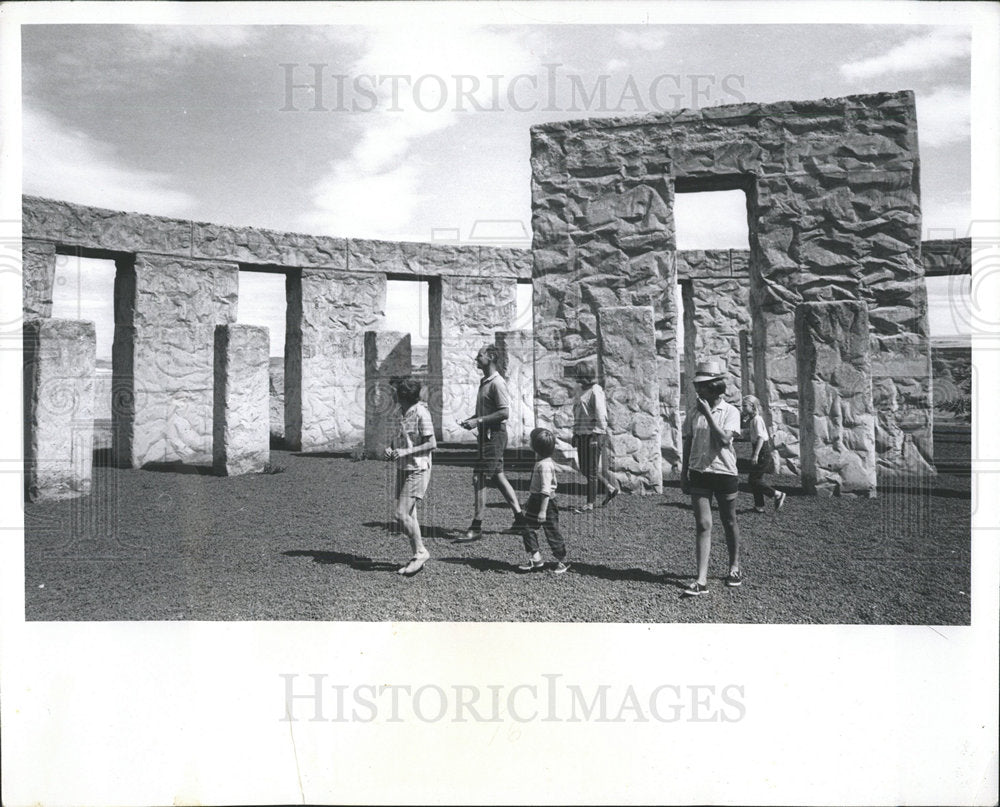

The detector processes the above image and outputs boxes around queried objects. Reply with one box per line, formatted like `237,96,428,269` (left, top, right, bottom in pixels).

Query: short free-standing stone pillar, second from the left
212,324,271,476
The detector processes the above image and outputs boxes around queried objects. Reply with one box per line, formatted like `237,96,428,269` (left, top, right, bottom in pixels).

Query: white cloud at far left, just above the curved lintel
22,108,195,216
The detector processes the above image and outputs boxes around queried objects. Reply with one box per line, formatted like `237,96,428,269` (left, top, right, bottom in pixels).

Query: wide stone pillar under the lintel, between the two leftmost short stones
111,253,239,468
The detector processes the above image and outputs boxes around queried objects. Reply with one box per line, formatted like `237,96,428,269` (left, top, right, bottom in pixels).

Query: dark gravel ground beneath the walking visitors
25,445,970,625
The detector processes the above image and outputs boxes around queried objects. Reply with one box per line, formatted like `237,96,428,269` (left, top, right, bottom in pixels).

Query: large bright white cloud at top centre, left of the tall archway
300,27,535,238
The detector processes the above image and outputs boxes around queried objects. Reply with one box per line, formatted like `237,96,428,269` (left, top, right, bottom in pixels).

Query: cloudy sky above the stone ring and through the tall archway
22,24,971,352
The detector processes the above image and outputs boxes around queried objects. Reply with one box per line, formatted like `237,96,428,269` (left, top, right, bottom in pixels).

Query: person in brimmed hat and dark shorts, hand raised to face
681,360,743,597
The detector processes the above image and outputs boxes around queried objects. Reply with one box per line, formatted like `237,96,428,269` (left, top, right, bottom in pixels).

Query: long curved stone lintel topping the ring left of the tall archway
23,196,531,278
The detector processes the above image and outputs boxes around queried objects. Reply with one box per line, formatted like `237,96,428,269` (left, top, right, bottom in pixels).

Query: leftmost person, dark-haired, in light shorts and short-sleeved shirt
385,378,437,577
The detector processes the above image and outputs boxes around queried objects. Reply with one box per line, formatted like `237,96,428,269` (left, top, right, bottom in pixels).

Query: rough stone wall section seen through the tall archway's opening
677,250,751,410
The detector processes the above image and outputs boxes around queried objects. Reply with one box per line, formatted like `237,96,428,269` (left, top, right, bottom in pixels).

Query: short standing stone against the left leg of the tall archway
597,306,663,493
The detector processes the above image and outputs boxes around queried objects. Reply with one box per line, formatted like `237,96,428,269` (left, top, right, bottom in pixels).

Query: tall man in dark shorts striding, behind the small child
461,345,524,541
